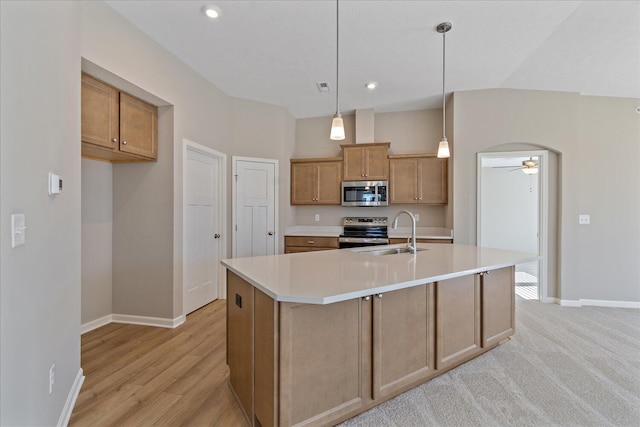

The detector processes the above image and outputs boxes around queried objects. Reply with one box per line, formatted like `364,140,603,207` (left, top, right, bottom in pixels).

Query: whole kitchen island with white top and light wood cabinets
222,244,537,426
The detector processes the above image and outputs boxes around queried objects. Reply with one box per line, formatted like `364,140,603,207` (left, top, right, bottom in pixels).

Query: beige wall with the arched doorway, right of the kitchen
453,89,640,303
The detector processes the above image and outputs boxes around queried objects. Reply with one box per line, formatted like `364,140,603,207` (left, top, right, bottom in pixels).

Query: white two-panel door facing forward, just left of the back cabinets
233,157,278,258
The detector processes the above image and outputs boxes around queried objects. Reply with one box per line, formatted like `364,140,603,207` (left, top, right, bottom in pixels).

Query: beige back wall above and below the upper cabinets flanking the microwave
294,110,448,227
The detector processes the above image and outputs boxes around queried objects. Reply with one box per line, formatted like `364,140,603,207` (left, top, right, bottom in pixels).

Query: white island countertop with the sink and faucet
221,243,538,304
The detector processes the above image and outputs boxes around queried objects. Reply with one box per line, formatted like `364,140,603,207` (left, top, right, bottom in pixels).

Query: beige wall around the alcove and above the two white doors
81,2,295,319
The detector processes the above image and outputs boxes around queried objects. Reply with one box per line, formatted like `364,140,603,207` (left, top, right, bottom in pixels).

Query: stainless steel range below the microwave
338,216,389,249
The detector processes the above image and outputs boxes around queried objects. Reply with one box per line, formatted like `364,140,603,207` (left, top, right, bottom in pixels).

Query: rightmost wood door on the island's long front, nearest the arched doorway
480,267,516,347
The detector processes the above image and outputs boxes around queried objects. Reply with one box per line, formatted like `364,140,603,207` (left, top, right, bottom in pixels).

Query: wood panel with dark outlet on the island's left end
227,270,254,420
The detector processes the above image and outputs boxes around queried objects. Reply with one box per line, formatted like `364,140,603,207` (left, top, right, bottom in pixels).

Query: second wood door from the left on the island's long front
373,283,435,400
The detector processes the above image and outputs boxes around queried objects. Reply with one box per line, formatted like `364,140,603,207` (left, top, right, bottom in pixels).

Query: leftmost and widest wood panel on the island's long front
279,298,371,426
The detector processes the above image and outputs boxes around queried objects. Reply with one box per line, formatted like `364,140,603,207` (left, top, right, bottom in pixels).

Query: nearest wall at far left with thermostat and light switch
0,1,81,426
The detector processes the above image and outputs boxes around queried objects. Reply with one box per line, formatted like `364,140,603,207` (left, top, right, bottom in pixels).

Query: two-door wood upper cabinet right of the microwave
389,154,448,205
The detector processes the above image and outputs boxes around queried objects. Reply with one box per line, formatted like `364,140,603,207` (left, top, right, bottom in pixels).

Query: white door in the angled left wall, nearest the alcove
183,141,226,315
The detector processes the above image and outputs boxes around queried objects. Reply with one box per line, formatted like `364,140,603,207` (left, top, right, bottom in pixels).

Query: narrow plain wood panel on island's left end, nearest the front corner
254,289,279,427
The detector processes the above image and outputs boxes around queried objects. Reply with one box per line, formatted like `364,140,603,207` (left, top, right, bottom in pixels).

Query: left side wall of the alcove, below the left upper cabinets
81,159,113,325
